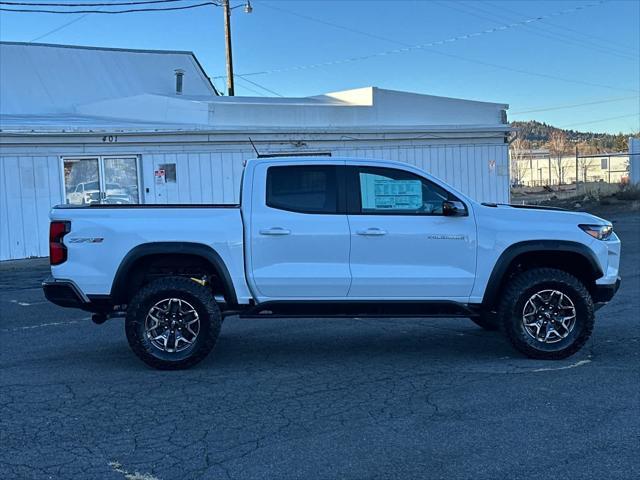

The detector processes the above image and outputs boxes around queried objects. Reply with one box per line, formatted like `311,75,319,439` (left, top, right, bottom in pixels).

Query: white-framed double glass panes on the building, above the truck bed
62,156,140,205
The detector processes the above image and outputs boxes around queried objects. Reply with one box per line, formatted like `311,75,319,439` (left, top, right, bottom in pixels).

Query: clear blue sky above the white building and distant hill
0,0,640,133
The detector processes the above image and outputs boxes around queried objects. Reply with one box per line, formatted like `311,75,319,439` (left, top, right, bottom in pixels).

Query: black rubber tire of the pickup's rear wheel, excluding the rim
125,277,222,370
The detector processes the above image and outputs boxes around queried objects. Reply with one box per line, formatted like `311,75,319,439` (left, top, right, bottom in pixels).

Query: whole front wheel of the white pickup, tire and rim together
498,268,595,360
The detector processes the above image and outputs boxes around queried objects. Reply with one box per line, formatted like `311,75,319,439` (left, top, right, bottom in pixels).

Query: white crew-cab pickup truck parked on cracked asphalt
43,157,620,369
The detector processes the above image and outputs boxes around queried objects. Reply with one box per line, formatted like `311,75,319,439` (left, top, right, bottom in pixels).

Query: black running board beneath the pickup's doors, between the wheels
234,300,478,318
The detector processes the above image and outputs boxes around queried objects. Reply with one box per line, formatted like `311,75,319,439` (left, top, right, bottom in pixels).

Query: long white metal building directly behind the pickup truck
0,42,509,260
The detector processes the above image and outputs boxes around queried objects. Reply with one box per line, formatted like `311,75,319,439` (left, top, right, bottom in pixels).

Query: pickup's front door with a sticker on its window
347,166,476,301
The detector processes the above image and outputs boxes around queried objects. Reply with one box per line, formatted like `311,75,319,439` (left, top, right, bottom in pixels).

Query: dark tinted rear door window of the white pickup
267,165,338,214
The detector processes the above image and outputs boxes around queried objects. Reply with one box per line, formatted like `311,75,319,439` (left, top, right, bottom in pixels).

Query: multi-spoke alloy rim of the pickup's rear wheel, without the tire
144,298,200,353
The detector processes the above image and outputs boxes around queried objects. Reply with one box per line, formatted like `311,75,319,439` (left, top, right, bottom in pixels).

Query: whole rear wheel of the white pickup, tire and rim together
125,277,222,370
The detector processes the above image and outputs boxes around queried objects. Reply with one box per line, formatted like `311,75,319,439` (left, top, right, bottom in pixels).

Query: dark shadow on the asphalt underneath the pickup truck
38,318,589,377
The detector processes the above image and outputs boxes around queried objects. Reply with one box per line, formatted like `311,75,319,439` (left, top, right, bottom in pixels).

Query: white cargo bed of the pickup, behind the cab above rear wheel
51,205,251,309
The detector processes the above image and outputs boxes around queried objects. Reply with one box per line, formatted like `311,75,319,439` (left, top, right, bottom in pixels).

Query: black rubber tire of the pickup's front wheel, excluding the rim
498,268,595,360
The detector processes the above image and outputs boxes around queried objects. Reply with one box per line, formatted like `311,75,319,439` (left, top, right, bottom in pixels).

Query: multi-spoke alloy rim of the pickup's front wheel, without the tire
522,290,576,343
